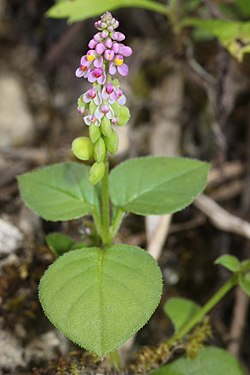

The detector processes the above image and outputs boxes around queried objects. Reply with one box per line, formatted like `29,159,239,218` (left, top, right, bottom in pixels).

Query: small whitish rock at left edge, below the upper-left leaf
0,218,23,257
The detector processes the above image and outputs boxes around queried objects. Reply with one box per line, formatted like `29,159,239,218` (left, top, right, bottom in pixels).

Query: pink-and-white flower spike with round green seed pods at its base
72,12,133,184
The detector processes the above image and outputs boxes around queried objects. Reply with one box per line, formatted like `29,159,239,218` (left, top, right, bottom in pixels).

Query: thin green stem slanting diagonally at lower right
168,274,238,346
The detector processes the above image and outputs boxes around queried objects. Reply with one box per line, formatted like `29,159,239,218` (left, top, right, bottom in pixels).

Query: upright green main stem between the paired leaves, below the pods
101,160,111,246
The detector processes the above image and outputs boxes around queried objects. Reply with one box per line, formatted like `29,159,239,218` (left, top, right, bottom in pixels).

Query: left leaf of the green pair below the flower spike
18,163,98,221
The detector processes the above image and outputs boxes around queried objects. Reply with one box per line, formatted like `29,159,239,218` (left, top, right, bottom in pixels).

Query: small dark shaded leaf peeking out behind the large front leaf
45,232,87,256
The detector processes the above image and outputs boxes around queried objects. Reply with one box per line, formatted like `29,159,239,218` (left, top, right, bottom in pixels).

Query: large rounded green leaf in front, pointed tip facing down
39,245,162,356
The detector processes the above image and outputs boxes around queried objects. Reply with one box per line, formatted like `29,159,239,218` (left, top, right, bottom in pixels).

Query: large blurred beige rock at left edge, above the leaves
0,74,34,149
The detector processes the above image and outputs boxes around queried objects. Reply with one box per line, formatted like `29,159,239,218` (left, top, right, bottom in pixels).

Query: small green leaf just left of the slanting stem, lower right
163,297,200,331
